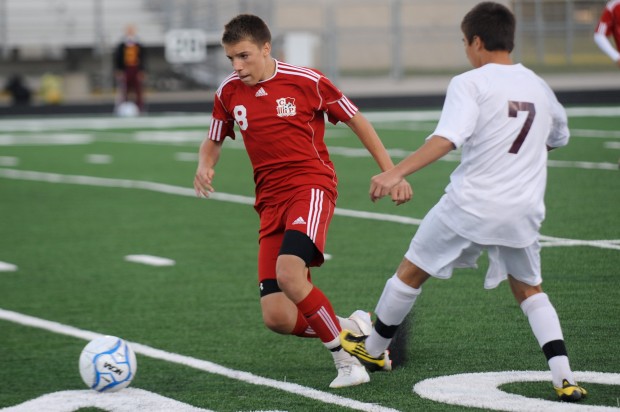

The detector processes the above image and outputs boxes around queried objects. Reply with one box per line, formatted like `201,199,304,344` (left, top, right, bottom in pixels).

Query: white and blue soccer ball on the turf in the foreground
80,336,138,392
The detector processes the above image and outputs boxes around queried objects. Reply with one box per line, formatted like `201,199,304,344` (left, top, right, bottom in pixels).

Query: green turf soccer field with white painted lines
0,107,620,412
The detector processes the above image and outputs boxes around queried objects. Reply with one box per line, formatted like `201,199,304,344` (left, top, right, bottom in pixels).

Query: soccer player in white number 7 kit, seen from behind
341,2,586,401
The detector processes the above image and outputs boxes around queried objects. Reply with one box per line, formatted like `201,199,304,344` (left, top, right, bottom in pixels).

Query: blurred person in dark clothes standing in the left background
114,25,146,112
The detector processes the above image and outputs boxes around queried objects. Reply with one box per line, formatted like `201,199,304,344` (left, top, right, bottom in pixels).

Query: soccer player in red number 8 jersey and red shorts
194,14,412,388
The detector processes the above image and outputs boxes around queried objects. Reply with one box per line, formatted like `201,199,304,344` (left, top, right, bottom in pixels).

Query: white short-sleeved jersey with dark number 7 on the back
433,64,569,248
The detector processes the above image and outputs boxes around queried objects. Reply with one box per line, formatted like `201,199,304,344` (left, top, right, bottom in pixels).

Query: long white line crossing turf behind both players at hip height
0,168,620,250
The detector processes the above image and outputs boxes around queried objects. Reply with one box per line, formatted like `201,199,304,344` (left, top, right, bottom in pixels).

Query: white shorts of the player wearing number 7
405,207,542,289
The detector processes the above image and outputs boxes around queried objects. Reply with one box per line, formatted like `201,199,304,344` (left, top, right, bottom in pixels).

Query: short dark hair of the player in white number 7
461,1,516,52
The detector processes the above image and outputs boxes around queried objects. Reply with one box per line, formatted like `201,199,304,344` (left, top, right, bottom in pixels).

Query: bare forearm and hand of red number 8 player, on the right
346,112,413,206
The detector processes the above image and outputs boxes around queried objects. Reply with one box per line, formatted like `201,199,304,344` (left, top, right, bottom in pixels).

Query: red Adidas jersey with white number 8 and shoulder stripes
209,61,358,211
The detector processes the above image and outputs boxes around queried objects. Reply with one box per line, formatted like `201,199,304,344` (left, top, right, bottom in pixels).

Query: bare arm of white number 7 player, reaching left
369,135,454,202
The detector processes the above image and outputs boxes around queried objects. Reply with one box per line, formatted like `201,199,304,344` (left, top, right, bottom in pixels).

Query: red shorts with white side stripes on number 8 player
258,188,335,282
